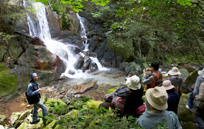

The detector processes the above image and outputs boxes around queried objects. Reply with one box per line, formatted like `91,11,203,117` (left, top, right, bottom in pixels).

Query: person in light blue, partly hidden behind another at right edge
186,68,204,110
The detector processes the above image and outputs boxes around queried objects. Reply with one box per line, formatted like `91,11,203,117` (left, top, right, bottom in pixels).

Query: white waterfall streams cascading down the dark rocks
24,1,108,78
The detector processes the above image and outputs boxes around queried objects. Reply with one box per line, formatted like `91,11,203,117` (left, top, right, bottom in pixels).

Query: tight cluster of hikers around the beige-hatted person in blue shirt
99,62,183,129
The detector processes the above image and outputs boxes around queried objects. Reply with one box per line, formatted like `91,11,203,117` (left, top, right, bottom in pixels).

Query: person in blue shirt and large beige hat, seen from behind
135,87,182,129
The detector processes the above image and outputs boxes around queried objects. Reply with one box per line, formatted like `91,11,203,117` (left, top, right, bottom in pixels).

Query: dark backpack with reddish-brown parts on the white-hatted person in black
104,87,129,114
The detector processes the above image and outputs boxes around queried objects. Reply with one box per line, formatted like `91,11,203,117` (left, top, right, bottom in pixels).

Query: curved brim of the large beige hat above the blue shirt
145,88,168,110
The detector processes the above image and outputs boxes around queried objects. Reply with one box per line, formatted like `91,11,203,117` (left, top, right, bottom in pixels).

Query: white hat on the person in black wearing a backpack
126,75,141,90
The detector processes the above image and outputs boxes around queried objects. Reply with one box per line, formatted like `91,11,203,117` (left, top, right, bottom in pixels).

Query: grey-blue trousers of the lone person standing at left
33,102,48,124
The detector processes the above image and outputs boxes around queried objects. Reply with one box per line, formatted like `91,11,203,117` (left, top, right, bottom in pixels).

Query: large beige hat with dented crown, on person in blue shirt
145,87,168,110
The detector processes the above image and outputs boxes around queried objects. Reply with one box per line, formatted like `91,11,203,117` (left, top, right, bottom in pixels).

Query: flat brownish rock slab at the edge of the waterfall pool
67,82,97,96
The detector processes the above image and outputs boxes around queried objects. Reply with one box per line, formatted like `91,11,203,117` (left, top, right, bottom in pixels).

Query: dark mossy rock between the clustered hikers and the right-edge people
177,93,195,122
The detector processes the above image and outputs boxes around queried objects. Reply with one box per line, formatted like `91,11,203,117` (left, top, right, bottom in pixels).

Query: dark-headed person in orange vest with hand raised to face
142,62,163,90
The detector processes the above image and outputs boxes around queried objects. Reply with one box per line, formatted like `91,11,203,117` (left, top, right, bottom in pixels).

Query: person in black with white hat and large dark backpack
99,75,143,116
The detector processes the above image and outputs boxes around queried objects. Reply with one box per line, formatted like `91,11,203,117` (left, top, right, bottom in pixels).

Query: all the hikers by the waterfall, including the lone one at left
26,62,204,129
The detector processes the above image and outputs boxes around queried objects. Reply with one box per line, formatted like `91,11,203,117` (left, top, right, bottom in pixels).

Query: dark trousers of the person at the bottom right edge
195,109,204,129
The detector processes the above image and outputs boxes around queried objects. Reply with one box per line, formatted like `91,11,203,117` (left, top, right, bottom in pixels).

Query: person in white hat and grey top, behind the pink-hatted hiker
168,67,183,96
